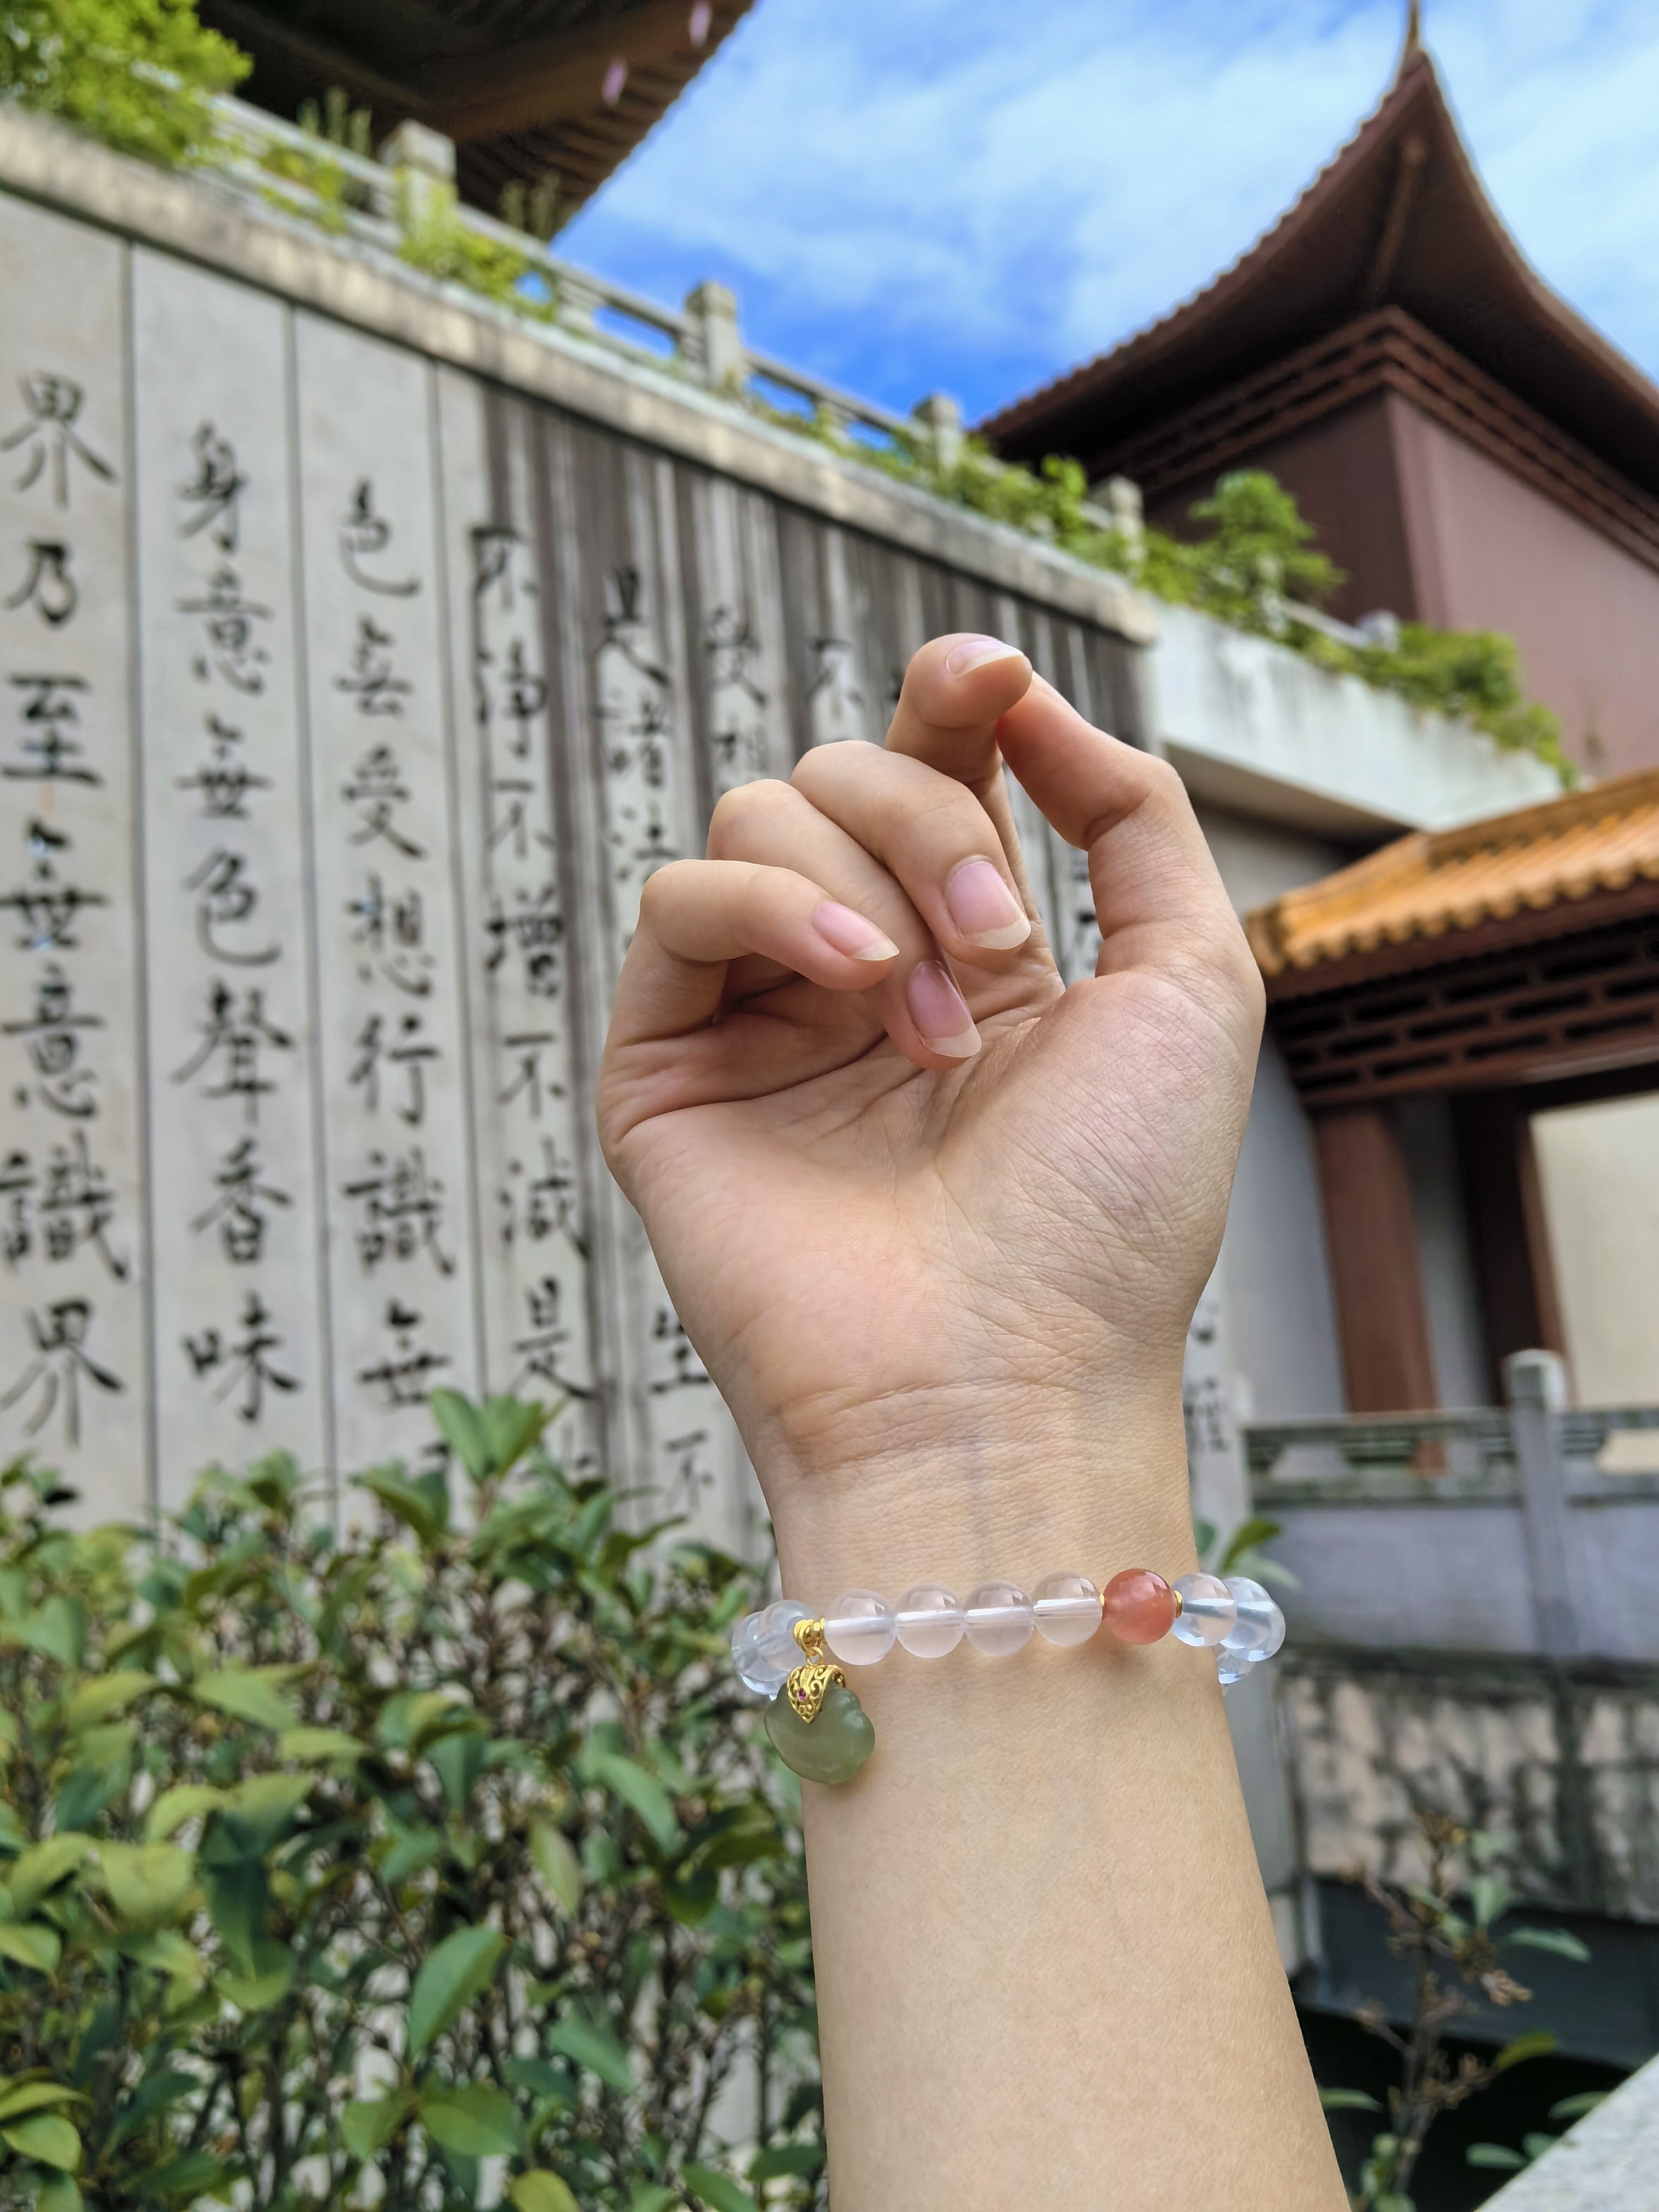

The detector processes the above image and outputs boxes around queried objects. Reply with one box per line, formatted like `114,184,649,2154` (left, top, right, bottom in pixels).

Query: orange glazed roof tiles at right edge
1245,767,1659,975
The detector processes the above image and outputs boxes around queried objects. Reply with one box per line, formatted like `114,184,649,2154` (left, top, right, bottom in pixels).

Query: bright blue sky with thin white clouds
559,0,1659,416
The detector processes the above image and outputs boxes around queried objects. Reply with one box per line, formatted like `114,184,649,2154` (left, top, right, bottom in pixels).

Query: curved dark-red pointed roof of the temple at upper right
980,38,1659,493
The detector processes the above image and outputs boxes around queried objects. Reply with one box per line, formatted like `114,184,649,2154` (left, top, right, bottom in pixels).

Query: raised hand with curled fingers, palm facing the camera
597,637,1263,1570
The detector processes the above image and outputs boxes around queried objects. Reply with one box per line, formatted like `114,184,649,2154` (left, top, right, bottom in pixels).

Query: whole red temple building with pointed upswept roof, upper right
982,24,1659,774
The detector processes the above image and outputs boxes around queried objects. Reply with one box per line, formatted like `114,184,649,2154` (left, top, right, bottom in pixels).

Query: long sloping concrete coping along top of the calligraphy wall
0,109,1159,644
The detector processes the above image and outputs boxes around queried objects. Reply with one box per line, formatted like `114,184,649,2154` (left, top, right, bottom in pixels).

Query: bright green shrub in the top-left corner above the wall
0,0,252,166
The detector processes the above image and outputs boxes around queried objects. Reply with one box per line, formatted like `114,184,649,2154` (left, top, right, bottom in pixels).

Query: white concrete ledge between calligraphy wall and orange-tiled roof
1152,606,1562,840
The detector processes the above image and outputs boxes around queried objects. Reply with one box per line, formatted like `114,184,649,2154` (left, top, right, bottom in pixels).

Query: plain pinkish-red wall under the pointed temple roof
1389,396,1659,774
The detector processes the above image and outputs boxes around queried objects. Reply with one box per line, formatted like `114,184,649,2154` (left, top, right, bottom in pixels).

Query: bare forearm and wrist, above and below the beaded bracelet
779,1385,1345,2212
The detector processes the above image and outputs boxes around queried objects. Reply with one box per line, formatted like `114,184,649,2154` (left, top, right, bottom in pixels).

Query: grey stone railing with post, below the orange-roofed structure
1243,1352,1659,1661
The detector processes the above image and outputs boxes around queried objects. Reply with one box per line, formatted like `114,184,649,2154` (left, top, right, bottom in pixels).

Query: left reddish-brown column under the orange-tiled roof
1314,1106,1440,1413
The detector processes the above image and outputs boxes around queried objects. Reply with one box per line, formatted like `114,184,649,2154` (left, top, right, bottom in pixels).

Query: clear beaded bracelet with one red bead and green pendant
732,1566,1285,1783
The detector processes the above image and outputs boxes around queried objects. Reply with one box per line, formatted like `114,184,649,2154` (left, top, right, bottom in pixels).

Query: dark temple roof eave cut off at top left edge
199,0,752,214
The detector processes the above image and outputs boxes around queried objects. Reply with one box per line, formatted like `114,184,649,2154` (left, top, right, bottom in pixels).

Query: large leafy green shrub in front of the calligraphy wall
0,1393,823,2212
